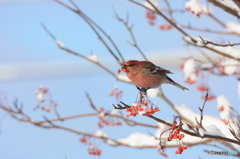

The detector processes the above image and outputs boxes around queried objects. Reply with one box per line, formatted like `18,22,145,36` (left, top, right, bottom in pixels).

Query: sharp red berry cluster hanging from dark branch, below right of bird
168,116,187,154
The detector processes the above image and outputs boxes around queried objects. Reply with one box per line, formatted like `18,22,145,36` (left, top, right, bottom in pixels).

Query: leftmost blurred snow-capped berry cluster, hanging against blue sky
33,85,58,112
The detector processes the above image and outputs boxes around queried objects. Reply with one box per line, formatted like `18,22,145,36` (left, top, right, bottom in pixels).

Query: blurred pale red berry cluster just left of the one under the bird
97,107,122,128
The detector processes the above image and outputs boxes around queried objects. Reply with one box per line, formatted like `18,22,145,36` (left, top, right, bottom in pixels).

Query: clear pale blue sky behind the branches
0,0,239,159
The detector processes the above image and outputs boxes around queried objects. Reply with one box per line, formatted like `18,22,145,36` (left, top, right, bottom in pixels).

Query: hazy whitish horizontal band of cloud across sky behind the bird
0,51,209,81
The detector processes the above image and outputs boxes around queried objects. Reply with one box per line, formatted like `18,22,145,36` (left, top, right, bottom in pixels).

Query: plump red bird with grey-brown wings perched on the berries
121,60,188,92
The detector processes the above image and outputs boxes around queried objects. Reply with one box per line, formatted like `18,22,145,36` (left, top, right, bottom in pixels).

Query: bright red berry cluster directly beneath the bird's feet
126,92,160,117
